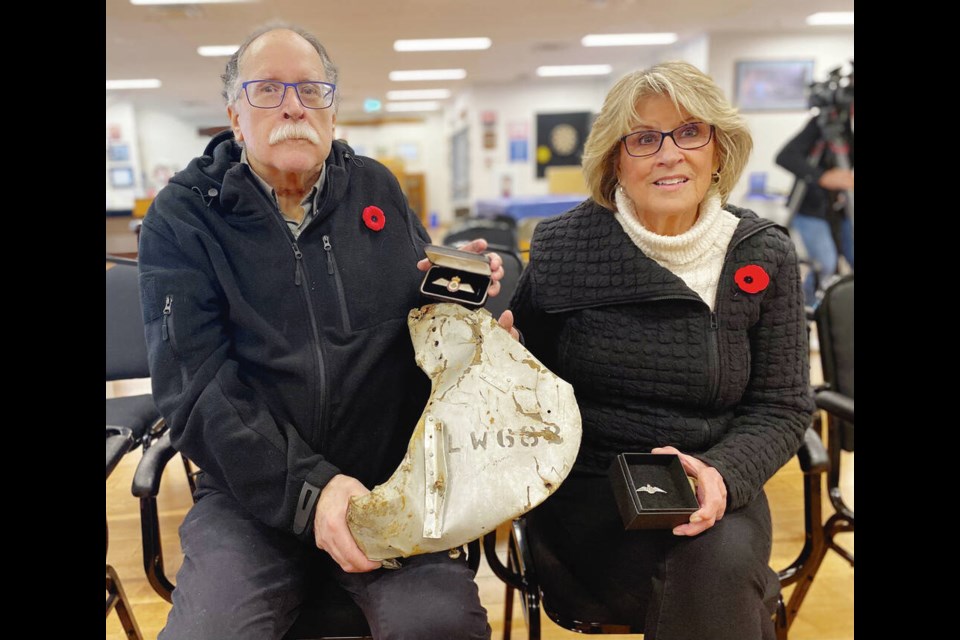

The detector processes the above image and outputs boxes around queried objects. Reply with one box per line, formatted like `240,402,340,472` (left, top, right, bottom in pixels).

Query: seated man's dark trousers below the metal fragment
159,491,490,640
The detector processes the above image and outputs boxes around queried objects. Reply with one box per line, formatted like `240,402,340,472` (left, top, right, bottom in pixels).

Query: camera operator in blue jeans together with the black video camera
776,64,853,306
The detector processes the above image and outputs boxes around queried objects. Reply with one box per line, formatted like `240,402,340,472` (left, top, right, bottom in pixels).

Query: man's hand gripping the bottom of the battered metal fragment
313,473,381,573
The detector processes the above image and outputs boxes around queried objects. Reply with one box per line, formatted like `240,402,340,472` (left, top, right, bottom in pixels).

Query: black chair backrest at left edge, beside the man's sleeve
106,260,150,381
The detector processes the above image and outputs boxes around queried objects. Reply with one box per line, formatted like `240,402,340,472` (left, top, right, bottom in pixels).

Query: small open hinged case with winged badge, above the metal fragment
420,244,491,307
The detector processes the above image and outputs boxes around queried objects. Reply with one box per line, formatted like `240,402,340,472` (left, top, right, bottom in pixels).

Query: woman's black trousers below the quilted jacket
527,474,780,640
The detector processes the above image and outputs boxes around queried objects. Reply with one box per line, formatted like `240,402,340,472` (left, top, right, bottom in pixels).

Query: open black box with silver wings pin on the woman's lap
608,453,700,529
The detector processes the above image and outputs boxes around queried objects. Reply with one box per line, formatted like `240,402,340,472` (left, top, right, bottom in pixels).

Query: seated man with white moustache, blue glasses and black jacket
140,26,511,640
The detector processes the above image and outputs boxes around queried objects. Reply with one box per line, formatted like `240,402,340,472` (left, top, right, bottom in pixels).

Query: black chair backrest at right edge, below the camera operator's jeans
814,274,854,451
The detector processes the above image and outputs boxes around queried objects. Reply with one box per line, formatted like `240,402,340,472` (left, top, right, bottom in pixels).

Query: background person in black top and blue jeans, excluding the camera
777,116,853,306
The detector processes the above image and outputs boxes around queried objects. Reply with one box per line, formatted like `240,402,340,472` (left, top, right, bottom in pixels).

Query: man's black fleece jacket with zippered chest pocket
139,132,429,538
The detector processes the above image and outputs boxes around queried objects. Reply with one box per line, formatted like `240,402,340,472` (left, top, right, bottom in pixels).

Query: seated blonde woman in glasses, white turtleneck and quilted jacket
511,62,813,640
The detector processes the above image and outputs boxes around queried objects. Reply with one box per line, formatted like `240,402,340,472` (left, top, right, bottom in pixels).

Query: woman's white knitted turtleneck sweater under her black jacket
614,189,740,311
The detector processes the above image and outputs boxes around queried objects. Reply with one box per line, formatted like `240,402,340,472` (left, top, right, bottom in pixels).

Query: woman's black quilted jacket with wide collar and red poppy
511,200,813,509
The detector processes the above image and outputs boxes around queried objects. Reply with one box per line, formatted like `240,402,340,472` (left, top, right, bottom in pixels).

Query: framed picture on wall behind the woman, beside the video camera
734,60,813,111
